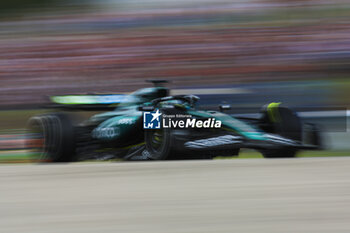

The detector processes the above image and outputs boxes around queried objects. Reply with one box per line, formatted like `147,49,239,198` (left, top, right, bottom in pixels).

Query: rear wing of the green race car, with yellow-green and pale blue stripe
47,94,127,111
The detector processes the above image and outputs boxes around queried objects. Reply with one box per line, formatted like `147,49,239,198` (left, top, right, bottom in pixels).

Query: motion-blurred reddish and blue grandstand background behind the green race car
0,0,350,161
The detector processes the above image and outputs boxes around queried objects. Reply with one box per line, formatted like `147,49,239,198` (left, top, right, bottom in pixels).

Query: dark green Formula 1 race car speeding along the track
28,82,322,162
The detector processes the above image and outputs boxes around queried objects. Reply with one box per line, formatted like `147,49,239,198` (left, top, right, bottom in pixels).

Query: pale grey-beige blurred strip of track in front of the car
0,157,350,233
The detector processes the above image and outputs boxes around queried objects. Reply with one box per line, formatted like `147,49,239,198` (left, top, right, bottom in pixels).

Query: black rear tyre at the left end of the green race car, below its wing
28,113,76,162
